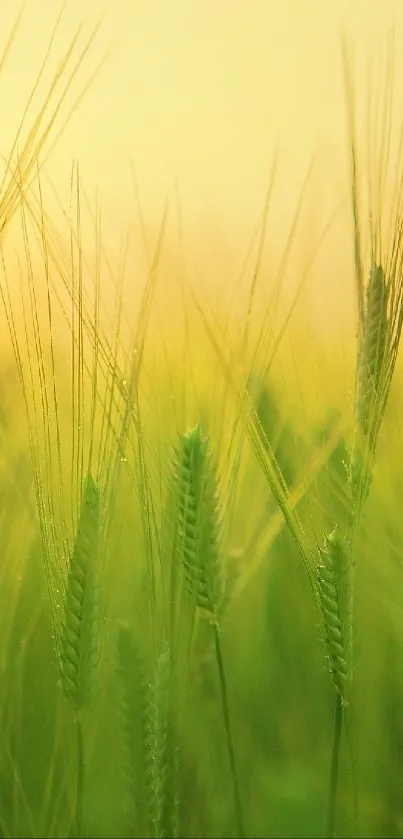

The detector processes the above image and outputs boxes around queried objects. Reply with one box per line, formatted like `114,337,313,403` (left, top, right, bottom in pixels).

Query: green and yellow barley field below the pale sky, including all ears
0,8,403,837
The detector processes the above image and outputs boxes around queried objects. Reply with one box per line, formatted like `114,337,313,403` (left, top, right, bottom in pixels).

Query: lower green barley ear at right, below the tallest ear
318,531,353,699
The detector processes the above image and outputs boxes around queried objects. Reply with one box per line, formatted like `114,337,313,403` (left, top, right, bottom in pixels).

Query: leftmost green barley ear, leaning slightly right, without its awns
60,474,100,709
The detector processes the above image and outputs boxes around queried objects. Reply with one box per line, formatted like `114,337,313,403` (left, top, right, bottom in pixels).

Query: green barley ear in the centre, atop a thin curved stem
174,425,224,622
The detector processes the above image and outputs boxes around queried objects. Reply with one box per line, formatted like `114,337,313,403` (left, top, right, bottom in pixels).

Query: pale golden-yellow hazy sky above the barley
0,0,403,334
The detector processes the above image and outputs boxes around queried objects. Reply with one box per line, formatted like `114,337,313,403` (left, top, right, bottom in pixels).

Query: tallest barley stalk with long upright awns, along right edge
328,34,403,831
